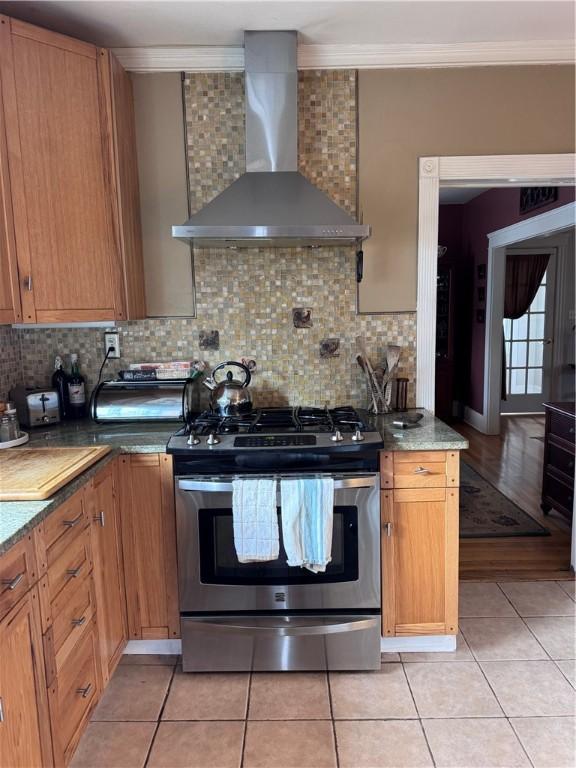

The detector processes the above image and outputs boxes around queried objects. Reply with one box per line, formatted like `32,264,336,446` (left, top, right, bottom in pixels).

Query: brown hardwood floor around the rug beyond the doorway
455,416,573,580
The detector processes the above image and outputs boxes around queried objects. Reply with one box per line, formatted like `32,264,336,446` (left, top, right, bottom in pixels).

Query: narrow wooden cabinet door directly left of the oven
120,454,180,640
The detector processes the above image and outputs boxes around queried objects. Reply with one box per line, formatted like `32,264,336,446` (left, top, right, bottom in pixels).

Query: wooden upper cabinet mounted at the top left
0,16,145,323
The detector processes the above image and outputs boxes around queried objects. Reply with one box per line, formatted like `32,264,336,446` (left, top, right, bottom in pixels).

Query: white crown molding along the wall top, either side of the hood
114,40,575,72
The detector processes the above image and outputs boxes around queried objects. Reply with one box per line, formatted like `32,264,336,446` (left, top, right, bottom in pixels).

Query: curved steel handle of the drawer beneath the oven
187,616,380,637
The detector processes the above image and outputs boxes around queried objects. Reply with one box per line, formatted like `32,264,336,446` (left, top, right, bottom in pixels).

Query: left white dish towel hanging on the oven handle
232,477,279,563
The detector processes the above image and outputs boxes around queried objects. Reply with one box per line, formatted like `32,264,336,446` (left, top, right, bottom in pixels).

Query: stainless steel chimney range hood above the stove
172,31,370,248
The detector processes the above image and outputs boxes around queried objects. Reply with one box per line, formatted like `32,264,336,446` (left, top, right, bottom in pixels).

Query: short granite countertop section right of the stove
368,408,468,451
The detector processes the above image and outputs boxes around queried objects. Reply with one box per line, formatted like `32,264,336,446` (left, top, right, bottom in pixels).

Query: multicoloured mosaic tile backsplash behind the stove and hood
0,71,416,406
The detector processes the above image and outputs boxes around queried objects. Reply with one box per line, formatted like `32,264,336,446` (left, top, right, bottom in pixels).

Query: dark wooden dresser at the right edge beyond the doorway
541,403,576,520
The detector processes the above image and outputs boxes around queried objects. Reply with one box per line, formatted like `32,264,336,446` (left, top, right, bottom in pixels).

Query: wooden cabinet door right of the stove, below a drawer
382,488,458,636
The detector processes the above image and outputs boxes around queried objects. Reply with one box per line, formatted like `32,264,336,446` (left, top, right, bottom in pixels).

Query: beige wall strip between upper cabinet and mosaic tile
132,72,196,317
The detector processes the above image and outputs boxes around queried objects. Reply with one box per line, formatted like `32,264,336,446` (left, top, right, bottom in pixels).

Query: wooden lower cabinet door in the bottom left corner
0,587,53,768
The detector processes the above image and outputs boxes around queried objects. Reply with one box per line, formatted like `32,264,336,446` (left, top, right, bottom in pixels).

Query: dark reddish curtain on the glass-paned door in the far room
502,253,550,400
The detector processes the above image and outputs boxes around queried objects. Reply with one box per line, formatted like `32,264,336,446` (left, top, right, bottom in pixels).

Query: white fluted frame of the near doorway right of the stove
416,153,576,412
